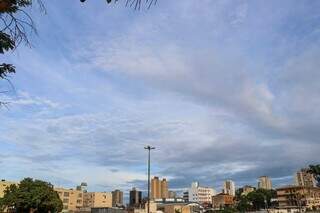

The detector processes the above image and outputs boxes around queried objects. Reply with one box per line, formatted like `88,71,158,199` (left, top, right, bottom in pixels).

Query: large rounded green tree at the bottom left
0,178,63,213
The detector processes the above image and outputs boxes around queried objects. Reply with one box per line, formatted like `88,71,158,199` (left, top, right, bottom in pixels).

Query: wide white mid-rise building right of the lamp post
188,182,215,203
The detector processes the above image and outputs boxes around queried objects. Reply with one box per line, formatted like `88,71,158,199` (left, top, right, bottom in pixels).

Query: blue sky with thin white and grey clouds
0,0,320,196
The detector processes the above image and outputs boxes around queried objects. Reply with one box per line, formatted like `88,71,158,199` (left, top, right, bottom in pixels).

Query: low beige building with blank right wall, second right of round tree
83,192,112,208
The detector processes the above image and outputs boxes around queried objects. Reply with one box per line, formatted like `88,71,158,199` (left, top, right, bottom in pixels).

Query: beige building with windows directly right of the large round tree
54,188,83,212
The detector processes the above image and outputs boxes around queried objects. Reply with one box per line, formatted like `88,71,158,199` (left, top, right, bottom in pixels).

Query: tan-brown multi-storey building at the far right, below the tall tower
277,186,320,210
